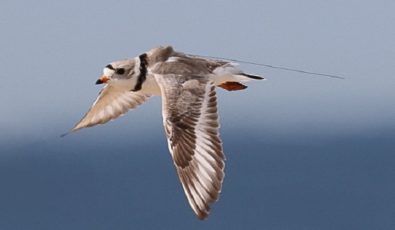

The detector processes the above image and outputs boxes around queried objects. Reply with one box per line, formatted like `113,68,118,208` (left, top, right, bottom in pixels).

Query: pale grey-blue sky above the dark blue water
0,1,395,141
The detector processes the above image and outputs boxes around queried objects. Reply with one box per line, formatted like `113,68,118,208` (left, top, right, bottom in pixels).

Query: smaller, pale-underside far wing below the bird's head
70,85,149,132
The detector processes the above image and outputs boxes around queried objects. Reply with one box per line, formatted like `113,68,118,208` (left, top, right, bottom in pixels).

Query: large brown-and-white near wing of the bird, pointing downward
155,74,225,219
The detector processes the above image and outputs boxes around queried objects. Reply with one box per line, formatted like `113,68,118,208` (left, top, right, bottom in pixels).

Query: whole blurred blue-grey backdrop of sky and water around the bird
0,0,395,230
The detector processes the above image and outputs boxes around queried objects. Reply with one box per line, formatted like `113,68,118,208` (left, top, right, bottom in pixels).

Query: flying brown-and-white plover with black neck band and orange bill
69,46,264,220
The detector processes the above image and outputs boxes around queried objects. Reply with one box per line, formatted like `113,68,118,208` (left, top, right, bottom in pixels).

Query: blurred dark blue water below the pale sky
0,130,395,229
